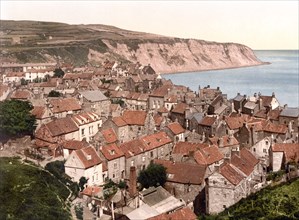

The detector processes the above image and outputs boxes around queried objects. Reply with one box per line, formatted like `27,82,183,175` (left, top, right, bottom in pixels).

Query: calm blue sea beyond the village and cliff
163,50,299,107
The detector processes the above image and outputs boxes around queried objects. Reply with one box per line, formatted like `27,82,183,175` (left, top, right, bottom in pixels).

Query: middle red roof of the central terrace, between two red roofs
119,139,147,158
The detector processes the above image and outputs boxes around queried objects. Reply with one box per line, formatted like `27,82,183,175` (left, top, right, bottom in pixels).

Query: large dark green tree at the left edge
0,100,36,137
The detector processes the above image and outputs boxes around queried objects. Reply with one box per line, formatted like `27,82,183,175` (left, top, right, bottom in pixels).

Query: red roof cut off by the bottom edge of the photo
147,207,197,220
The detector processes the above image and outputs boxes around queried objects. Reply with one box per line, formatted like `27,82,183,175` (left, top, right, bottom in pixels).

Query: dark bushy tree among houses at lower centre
138,163,167,188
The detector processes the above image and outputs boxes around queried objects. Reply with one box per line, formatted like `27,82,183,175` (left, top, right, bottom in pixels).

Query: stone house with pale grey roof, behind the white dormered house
78,90,111,117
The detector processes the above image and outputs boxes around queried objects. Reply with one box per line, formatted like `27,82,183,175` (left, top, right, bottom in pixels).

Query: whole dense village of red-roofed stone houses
0,60,299,220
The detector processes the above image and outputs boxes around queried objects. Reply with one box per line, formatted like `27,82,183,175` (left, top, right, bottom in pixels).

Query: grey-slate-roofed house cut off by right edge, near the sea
279,106,299,133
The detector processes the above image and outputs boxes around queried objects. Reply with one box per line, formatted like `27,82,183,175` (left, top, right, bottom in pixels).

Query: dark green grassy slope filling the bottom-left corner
0,158,70,220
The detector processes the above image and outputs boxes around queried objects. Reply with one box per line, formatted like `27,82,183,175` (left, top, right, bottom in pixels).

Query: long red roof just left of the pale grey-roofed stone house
49,98,81,113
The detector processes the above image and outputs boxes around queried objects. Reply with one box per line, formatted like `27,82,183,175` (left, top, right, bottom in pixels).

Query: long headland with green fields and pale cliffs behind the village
0,20,262,73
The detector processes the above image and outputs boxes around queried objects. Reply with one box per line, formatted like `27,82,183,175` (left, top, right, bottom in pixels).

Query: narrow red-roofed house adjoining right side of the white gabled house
100,144,126,183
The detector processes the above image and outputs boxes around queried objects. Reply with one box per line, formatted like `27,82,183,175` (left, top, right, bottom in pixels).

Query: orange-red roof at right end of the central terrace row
140,131,172,150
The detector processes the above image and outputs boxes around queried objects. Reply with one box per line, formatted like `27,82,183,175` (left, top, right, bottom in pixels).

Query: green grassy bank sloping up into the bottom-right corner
200,179,299,219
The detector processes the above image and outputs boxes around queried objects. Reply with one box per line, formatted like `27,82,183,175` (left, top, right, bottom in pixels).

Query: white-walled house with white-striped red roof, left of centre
71,112,102,142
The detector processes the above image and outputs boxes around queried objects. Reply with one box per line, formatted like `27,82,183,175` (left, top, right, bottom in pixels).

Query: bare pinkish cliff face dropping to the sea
104,39,261,73
